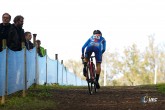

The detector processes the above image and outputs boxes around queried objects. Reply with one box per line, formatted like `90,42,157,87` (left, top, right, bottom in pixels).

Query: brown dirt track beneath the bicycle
52,87,165,110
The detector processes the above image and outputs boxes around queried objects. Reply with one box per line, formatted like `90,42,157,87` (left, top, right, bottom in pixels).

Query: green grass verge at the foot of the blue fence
0,86,57,110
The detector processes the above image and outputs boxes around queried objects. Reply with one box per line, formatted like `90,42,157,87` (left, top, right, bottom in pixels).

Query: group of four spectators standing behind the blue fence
0,13,46,57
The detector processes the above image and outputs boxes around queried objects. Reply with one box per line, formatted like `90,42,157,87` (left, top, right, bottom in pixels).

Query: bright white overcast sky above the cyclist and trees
0,0,165,61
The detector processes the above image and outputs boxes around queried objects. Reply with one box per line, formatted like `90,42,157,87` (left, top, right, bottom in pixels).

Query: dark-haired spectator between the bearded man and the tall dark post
25,32,34,50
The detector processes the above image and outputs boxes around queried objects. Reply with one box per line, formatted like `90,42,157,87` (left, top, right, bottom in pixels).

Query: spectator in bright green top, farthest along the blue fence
35,40,46,57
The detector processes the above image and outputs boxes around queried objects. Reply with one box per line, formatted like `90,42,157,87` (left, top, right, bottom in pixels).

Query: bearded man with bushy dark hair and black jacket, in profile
7,15,25,51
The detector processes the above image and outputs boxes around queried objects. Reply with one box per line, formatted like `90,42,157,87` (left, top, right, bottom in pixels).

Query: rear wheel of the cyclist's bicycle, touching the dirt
86,67,95,95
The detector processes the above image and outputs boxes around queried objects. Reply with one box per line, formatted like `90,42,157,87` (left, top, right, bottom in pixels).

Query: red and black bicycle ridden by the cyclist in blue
82,56,97,95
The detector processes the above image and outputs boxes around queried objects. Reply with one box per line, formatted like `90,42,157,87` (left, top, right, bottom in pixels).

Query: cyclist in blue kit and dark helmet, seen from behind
81,30,106,89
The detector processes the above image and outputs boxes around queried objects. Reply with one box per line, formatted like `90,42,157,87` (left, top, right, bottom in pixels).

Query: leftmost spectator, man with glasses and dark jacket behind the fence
0,13,11,52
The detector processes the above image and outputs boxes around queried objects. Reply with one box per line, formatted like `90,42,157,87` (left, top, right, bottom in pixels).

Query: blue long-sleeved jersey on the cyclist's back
82,36,106,55
